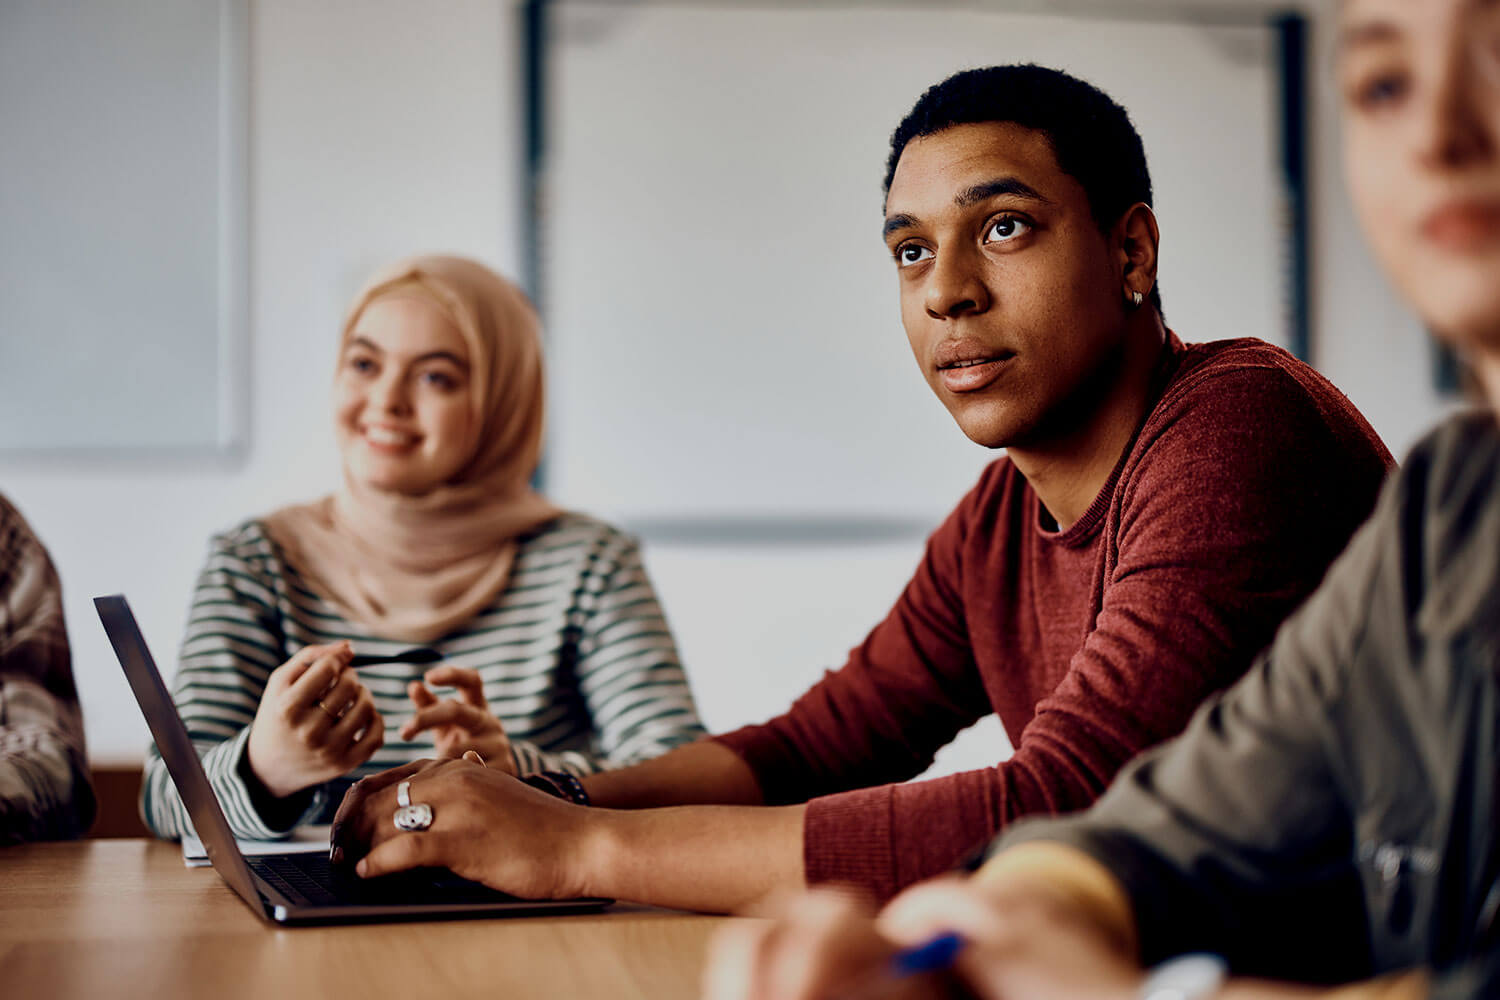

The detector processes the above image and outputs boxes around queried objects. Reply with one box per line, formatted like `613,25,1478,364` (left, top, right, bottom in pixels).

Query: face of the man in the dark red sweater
885,123,1125,448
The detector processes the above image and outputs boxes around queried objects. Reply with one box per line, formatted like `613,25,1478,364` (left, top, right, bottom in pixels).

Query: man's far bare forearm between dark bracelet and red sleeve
584,739,764,810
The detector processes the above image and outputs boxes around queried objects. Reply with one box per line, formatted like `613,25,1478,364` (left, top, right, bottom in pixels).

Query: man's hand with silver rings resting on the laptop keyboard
332,754,602,900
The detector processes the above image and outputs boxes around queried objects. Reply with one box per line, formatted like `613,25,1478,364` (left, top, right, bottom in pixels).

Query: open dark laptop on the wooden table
95,595,612,925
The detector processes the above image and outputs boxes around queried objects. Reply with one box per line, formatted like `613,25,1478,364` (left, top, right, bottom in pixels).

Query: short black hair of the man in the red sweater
884,63,1161,310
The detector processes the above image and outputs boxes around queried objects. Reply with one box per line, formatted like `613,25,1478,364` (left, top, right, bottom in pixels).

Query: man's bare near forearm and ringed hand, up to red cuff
333,760,807,912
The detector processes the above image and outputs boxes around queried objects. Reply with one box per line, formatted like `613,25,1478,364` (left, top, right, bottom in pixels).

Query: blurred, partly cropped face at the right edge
1338,0,1500,364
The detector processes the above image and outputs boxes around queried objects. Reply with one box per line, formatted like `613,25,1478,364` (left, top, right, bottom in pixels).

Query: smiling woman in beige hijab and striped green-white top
141,256,702,838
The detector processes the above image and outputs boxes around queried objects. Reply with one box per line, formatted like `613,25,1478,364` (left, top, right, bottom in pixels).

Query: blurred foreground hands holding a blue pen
704,876,1143,1000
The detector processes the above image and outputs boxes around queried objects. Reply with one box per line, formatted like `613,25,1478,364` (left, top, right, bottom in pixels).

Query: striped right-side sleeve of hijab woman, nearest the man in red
512,531,704,775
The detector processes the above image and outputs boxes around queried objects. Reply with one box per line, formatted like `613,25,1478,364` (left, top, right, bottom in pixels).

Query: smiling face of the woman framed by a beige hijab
333,291,477,496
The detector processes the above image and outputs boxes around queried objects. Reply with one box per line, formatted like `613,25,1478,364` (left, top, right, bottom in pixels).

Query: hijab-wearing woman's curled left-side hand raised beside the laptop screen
246,642,386,799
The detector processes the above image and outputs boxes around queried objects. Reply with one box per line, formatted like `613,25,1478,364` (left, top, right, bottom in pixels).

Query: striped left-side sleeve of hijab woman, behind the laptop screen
141,532,326,840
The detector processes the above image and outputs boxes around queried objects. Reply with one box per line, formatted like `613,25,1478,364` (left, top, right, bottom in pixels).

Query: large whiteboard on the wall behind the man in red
539,1,1287,525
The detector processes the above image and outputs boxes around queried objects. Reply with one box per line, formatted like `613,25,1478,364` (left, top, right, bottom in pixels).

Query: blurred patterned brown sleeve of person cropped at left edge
0,498,95,844
